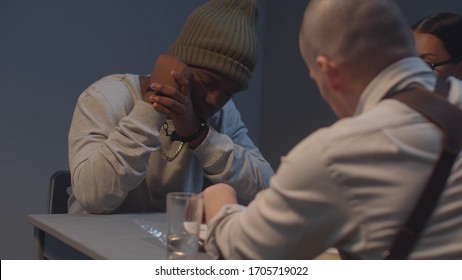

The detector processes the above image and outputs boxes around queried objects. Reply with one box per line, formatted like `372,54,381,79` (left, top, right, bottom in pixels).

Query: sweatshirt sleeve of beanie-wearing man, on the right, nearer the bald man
192,101,274,205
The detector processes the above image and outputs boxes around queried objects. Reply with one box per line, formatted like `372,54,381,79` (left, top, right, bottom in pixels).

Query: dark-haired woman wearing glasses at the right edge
412,13,462,80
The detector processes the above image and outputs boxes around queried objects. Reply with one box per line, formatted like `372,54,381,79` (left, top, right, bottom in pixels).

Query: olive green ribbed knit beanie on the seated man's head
168,0,258,90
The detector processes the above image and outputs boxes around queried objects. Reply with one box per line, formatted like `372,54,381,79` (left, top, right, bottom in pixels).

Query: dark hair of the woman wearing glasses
412,13,462,58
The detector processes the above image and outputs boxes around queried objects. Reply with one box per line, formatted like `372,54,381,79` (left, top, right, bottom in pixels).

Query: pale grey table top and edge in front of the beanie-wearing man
28,213,175,260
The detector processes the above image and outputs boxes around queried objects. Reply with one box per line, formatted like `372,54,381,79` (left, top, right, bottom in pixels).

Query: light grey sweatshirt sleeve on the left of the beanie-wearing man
68,76,164,213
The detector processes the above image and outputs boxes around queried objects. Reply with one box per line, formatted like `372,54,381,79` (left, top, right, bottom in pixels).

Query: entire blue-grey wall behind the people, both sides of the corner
0,0,462,259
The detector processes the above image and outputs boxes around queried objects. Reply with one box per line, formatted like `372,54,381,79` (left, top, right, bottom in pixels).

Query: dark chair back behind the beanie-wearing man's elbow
48,170,71,214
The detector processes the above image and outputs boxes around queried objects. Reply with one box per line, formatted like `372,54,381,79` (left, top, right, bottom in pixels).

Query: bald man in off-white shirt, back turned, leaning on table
203,0,462,259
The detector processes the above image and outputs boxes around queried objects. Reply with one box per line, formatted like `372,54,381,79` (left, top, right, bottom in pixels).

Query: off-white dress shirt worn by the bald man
206,57,462,259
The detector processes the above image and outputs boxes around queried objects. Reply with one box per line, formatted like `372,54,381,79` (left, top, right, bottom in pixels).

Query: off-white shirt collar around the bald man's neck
354,57,436,116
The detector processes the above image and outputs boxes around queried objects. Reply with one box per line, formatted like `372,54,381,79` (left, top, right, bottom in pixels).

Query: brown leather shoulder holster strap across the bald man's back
385,80,462,259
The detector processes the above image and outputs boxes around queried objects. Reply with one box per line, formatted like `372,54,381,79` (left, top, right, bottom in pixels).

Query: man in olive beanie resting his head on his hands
68,0,274,213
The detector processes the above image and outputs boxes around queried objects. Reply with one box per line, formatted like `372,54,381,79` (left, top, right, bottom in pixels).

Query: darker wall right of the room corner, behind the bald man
260,0,462,169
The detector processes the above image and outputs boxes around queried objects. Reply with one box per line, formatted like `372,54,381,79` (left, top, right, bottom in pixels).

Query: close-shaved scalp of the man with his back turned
300,0,414,73
